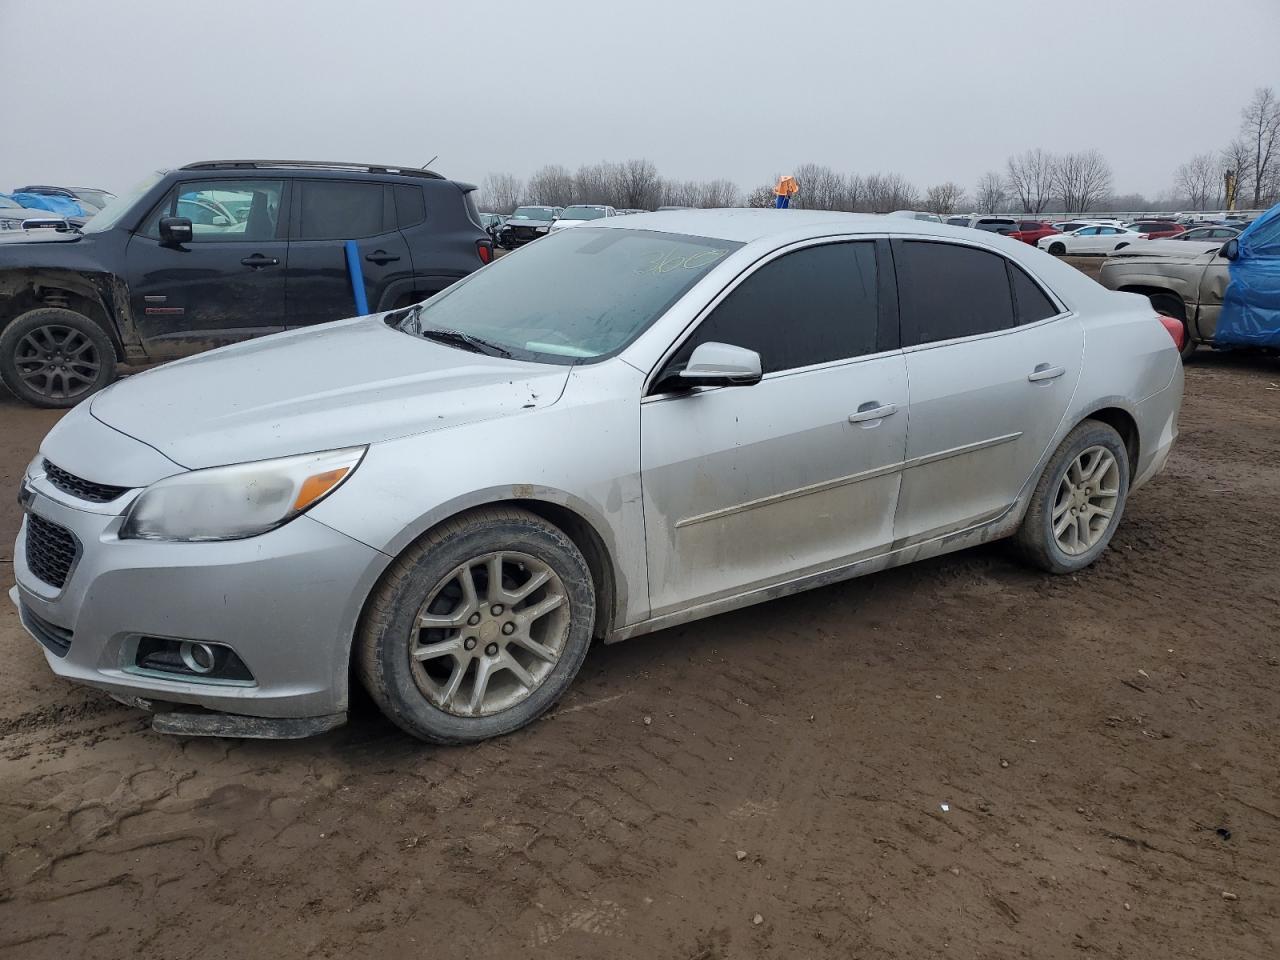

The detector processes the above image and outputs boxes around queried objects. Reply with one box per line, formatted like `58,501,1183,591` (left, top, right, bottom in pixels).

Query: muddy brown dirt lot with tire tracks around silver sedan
0,335,1280,960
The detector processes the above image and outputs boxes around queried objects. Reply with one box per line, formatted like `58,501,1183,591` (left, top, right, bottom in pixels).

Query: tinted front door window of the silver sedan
669,241,878,374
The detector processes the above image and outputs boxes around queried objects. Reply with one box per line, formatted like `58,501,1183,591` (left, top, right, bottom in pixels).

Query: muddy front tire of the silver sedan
356,507,595,744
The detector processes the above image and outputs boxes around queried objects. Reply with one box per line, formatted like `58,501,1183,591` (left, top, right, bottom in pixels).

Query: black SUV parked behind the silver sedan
0,160,493,407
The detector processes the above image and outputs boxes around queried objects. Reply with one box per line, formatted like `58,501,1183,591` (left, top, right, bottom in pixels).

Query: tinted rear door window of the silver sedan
893,241,1014,347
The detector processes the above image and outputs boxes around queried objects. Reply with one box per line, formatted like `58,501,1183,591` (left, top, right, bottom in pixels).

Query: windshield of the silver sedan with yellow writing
401,228,742,364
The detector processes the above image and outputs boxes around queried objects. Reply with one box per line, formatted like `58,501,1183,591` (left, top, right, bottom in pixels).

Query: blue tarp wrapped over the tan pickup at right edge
1213,204,1280,347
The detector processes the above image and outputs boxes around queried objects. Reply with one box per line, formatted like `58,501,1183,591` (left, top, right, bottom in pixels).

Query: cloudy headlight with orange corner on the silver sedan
120,447,369,540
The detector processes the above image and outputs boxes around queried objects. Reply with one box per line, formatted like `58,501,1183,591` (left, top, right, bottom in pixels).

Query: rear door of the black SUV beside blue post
287,178,413,326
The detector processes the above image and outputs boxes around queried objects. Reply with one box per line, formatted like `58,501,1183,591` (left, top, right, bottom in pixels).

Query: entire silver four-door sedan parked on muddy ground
12,210,1183,742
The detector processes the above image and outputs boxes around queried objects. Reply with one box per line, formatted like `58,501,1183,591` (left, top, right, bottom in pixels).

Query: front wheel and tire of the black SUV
0,307,115,407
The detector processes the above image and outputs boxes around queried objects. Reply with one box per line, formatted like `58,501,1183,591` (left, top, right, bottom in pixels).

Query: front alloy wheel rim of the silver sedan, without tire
408,550,570,717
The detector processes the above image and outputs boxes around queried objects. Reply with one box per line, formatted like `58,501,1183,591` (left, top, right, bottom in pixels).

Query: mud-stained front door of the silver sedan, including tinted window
640,242,908,616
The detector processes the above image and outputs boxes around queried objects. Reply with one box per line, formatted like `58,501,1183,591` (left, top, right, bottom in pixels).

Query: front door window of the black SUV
142,179,284,242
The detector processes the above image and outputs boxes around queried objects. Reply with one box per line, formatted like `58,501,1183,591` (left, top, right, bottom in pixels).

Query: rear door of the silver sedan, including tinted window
893,239,1084,545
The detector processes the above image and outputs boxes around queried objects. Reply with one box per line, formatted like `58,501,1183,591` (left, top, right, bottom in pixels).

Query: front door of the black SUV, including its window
125,178,289,360
